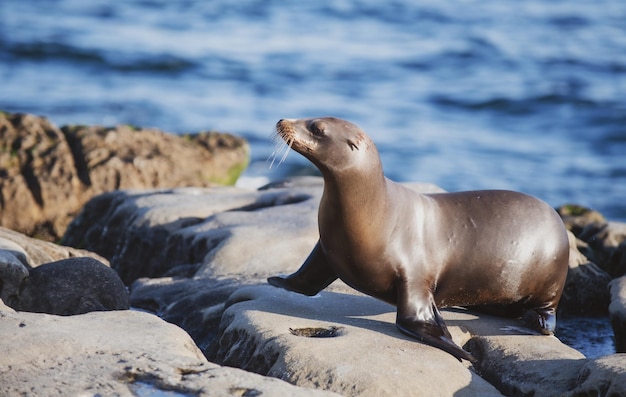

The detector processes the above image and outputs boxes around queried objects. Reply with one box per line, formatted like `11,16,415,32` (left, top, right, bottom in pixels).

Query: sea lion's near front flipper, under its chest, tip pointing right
396,295,476,363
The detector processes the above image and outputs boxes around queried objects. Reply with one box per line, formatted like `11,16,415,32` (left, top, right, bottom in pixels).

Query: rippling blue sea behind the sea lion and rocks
0,0,626,221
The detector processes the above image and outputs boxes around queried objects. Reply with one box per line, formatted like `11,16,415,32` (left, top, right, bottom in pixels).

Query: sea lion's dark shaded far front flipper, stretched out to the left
267,241,337,296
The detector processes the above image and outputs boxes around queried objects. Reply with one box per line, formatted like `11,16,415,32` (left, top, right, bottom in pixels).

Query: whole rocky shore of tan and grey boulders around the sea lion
0,114,626,396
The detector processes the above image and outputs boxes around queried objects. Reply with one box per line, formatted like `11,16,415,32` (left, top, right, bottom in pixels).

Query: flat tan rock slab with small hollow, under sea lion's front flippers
207,285,501,396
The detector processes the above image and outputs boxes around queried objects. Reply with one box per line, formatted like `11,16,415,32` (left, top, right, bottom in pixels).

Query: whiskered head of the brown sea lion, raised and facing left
276,117,379,173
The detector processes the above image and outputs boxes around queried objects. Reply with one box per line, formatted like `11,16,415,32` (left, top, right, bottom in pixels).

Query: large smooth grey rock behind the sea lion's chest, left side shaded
62,177,440,284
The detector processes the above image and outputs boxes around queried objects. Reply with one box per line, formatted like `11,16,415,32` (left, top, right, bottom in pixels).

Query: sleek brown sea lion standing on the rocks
268,117,569,362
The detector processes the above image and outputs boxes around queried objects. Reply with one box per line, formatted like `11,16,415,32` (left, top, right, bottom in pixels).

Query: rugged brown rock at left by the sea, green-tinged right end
0,112,249,240
